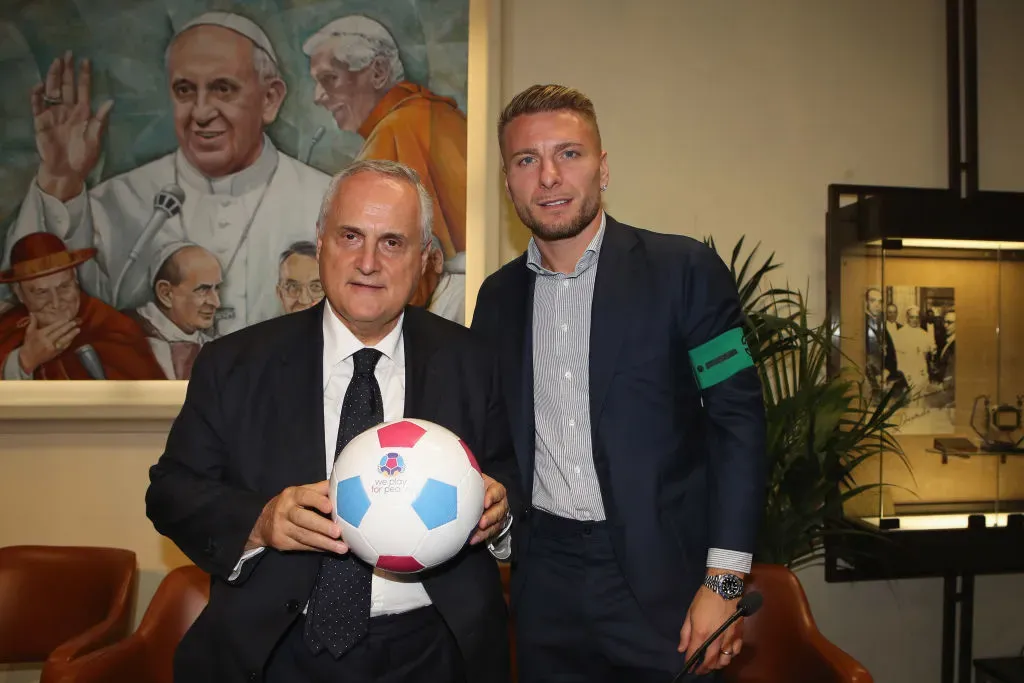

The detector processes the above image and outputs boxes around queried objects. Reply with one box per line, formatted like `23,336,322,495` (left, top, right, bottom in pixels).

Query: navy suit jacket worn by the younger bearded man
473,216,766,637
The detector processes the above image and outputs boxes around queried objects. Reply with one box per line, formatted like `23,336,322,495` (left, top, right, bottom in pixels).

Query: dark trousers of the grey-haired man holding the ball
264,606,466,683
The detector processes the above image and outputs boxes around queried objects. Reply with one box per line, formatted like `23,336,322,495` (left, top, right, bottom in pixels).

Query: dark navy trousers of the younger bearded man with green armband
515,510,713,683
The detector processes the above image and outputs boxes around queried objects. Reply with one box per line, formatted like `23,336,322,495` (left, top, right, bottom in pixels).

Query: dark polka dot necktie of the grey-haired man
303,348,384,658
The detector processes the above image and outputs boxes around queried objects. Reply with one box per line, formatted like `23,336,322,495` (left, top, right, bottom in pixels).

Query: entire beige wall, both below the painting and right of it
0,0,1024,683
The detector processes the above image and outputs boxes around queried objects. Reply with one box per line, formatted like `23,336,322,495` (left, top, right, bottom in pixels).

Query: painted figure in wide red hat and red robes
0,232,164,380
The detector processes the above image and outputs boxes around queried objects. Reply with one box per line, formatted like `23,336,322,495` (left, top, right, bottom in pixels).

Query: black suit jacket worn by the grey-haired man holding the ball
146,303,519,683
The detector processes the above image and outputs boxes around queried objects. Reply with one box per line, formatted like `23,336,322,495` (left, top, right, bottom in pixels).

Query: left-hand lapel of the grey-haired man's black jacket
273,299,327,483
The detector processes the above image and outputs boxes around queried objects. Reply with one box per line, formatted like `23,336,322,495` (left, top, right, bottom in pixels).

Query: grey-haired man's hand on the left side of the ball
246,479,350,554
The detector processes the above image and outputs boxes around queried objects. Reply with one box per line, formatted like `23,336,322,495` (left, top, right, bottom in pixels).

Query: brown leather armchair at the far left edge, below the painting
0,546,136,683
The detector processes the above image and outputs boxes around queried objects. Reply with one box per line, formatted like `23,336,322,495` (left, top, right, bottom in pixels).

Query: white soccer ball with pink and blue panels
330,419,483,572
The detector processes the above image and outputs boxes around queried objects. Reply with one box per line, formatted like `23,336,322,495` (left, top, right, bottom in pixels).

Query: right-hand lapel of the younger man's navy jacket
590,216,638,438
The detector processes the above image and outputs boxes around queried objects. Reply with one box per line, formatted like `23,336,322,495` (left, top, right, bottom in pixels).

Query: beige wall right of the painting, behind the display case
501,0,1024,683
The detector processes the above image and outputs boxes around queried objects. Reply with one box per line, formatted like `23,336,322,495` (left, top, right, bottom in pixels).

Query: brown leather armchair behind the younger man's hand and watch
722,564,872,683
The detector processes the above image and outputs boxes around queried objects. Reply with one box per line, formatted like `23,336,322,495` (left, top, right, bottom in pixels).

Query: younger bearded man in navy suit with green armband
473,85,766,683
